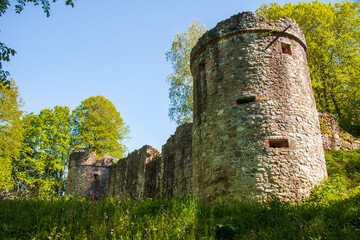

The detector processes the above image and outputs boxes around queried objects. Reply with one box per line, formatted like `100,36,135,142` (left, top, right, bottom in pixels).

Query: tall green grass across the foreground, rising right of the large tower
0,150,360,240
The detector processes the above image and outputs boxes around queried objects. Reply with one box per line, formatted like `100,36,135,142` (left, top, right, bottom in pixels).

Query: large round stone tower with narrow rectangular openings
191,12,327,201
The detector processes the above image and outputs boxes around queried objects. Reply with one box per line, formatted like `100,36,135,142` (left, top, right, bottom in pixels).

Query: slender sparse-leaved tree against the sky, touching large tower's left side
166,20,206,125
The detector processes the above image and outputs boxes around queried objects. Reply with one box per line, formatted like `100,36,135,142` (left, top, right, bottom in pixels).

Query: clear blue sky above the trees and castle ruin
0,0,346,152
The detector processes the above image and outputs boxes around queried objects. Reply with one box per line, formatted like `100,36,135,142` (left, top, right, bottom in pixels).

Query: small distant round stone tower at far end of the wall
66,151,113,196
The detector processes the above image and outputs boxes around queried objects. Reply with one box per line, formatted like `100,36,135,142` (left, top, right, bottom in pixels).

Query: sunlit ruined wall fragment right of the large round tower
319,113,360,151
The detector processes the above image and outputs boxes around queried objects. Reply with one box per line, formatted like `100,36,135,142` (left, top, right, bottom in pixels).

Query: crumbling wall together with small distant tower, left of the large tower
66,123,192,198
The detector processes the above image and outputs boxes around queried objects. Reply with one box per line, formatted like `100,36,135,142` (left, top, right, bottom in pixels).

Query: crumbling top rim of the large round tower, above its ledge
190,12,307,65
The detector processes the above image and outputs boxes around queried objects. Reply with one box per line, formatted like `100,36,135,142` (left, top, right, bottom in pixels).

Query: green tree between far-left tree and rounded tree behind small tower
13,106,71,196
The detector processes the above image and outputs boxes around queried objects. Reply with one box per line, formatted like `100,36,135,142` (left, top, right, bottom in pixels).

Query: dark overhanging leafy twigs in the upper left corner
0,0,74,86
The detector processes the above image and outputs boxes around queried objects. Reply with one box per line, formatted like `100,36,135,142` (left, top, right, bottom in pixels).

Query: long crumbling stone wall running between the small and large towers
108,123,192,198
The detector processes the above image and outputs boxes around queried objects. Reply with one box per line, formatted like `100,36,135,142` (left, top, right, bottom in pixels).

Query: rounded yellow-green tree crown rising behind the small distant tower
71,96,129,158
